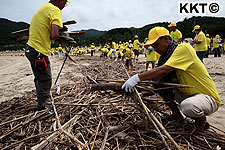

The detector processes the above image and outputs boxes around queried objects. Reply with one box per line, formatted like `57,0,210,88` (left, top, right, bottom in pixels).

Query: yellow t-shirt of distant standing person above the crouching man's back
195,31,208,51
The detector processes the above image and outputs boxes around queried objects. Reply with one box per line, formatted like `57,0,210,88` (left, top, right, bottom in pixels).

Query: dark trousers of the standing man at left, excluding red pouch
25,45,52,108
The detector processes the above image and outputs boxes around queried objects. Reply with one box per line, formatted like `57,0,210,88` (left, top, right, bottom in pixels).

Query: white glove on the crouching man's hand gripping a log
122,74,140,93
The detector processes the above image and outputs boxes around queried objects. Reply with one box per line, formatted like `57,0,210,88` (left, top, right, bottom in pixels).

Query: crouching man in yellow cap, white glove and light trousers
122,27,221,129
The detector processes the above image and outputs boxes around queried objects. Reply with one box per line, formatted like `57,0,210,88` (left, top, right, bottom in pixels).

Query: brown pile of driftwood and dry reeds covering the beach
0,57,225,150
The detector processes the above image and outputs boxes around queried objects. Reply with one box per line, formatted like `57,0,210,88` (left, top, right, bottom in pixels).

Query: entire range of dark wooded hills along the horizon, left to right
0,17,225,50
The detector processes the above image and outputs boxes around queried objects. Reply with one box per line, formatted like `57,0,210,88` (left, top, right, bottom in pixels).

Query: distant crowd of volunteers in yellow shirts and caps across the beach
46,22,225,71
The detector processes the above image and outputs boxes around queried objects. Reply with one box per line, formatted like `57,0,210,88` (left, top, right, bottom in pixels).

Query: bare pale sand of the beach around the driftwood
0,55,225,131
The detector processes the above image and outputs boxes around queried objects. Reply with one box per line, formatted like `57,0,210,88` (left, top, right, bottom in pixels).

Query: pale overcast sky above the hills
0,0,225,31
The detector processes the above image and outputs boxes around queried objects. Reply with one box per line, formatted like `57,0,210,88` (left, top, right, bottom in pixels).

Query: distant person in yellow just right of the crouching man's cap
168,22,182,43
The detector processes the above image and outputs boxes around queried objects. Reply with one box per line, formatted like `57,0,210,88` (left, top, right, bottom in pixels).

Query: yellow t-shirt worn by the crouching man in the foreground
165,43,221,105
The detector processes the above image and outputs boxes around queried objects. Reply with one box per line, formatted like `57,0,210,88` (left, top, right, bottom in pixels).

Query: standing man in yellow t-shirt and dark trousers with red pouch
25,0,69,111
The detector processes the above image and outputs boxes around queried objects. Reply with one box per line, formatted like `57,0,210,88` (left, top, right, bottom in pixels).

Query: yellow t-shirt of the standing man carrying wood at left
27,3,63,56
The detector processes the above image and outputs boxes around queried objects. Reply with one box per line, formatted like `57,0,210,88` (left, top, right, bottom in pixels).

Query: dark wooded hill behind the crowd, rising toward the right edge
96,17,225,43
